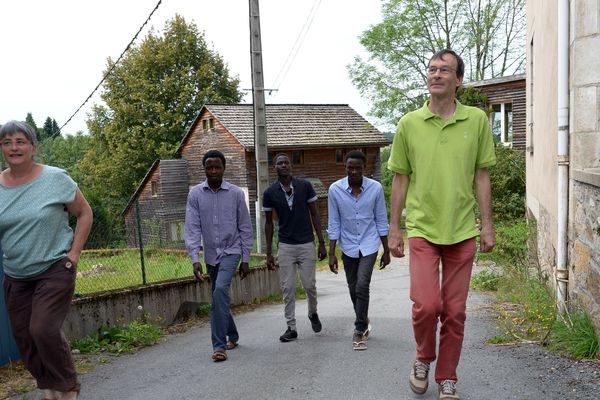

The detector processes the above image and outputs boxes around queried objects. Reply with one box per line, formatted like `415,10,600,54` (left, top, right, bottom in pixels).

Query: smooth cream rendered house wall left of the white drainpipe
525,0,558,276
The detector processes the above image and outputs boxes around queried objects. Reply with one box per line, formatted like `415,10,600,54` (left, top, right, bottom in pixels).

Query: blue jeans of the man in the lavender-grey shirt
206,254,241,351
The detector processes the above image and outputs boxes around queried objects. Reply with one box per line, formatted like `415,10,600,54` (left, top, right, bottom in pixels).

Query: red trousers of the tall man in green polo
408,237,476,383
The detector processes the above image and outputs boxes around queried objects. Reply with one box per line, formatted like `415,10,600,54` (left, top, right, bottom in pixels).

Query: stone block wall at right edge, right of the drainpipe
569,0,600,335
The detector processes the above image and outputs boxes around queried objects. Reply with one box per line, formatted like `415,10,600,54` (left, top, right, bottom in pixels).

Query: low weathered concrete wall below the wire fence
63,267,281,340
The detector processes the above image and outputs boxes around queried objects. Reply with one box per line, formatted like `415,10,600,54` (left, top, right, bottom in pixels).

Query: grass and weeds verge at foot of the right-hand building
471,219,600,359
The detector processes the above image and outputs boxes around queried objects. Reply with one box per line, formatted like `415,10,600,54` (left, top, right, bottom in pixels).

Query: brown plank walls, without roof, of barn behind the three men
126,106,390,245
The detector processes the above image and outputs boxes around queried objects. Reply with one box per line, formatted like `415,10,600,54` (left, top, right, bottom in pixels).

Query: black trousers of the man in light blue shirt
342,252,377,333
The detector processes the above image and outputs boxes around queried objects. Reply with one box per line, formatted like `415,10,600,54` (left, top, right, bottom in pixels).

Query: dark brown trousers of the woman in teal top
4,258,78,392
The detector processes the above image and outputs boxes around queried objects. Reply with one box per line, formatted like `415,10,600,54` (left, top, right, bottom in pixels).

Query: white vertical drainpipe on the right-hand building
554,0,569,313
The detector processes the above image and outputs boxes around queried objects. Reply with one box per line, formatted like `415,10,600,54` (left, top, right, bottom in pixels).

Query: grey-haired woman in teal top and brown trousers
0,121,93,400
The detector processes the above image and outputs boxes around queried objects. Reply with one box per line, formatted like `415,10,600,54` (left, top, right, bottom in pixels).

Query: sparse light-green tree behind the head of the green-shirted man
348,0,525,125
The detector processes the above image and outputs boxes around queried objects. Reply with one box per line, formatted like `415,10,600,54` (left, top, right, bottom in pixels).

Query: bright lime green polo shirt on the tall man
388,101,496,244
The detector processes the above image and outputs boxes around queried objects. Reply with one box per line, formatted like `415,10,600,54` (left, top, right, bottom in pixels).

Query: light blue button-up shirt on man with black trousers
327,176,389,258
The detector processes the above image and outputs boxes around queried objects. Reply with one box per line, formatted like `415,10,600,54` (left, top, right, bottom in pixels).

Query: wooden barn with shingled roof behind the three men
123,104,390,247
